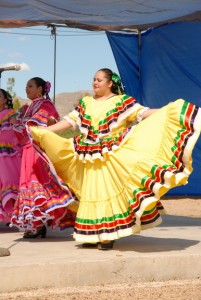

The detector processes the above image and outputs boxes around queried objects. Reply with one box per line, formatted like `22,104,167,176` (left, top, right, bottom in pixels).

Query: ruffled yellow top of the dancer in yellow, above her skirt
67,95,145,161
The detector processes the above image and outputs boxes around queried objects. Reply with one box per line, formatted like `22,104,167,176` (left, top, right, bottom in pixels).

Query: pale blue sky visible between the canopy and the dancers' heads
0,26,118,99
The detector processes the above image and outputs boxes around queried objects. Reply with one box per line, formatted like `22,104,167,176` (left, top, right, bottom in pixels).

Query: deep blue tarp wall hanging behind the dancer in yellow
107,22,201,196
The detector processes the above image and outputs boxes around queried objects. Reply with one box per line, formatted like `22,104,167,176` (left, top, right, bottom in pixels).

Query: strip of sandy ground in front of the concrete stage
0,280,201,300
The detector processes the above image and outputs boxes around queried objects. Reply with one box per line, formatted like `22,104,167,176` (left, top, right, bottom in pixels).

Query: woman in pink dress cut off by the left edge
0,89,21,223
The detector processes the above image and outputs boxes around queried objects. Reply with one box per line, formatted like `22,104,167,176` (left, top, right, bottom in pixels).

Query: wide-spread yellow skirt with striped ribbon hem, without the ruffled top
31,99,201,243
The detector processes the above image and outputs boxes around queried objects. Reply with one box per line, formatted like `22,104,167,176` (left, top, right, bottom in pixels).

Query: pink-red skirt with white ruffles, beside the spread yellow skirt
11,143,75,231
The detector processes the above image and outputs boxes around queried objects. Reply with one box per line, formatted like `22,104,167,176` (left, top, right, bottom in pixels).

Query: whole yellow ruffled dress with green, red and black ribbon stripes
31,95,201,243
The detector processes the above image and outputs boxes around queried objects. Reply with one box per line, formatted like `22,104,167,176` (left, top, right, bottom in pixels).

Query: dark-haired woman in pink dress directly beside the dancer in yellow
11,77,75,238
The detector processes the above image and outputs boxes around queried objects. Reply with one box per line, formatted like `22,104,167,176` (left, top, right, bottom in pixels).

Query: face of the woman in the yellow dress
92,71,112,96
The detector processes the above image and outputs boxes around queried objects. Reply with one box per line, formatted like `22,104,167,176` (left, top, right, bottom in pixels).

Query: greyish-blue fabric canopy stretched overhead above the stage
0,0,201,31
